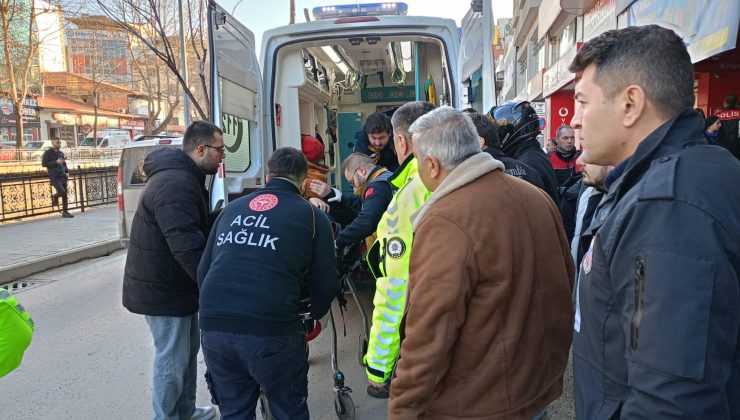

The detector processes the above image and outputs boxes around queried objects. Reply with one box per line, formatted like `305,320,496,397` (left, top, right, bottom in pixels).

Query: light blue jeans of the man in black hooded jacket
146,313,200,420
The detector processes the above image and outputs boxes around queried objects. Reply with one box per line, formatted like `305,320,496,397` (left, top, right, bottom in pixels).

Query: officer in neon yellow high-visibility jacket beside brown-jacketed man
364,102,436,398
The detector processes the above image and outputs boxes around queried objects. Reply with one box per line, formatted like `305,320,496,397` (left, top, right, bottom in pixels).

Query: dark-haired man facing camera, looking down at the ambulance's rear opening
354,112,399,172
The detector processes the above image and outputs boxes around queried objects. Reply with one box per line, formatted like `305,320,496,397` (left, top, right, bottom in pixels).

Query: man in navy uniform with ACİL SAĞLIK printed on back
198,147,338,420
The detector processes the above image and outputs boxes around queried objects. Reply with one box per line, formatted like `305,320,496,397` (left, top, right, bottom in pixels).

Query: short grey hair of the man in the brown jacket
409,106,480,171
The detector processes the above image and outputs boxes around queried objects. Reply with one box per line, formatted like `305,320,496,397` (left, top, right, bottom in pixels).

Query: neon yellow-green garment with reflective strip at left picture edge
0,288,35,378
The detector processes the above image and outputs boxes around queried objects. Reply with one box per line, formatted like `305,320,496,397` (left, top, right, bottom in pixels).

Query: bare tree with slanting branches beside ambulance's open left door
97,0,209,119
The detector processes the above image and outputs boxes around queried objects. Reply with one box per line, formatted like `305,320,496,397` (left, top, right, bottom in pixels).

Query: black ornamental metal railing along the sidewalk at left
0,166,118,222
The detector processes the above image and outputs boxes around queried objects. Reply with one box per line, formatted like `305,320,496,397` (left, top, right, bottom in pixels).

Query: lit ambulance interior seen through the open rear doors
268,36,452,189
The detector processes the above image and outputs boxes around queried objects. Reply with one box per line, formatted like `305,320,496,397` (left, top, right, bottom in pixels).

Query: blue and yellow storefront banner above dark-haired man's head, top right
628,0,740,63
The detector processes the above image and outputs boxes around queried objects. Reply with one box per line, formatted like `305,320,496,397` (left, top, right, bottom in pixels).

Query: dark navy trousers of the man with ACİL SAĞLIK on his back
201,331,309,420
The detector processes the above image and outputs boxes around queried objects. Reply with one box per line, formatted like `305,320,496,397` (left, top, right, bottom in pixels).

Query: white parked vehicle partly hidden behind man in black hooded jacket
118,137,182,248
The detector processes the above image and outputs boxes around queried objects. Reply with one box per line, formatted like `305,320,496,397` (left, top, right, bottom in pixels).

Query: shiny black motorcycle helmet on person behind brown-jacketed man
488,100,540,152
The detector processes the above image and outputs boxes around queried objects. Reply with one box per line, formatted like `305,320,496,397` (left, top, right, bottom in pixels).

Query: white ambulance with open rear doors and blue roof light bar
208,0,494,210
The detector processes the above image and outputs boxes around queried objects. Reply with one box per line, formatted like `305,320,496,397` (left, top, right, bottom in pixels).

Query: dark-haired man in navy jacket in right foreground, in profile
570,25,740,419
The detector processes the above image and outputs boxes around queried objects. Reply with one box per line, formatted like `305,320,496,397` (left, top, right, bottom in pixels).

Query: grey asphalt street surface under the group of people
0,251,573,420
